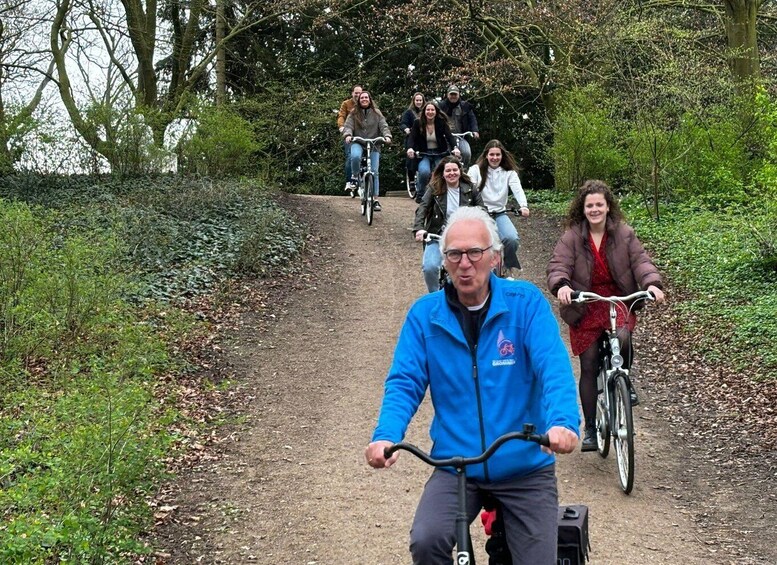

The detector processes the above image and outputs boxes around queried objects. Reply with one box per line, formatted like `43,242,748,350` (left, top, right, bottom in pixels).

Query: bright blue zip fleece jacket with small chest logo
372,275,579,482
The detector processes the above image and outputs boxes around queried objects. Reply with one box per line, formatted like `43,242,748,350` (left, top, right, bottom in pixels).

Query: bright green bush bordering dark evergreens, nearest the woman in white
553,85,626,189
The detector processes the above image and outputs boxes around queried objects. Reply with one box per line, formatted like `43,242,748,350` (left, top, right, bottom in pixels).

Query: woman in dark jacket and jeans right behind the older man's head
413,157,483,292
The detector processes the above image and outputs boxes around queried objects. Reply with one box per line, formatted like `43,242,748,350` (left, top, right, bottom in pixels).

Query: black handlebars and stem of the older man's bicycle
383,424,550,565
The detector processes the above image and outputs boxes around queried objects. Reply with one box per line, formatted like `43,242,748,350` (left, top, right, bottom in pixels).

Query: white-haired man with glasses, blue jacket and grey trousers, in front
365,207,579,565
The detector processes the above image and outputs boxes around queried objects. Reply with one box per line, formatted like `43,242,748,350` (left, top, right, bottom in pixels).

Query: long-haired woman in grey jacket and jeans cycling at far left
342,90,391,212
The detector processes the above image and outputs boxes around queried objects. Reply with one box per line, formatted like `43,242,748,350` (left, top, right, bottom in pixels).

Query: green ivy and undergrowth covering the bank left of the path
0,176,304,565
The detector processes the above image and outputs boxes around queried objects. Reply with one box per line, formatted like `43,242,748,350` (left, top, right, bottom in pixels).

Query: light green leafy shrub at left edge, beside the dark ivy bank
0,201,121,360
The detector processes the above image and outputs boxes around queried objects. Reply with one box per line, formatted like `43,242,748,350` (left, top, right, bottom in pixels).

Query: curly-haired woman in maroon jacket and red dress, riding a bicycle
547,180,664,451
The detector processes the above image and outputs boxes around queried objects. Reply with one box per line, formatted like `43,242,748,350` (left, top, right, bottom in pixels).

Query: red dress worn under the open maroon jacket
569,232,637,355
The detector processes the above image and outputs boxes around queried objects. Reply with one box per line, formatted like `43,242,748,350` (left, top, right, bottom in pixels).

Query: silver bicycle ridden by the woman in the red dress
572,290,655,494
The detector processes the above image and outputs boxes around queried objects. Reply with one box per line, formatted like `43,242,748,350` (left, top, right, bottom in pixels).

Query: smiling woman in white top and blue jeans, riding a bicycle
467,139,529,278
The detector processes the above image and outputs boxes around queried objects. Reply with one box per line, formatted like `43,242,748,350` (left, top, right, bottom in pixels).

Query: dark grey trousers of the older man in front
410,465,558,565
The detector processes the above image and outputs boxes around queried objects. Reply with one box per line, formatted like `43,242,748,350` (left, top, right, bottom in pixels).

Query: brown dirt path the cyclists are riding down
149,193,777,565
